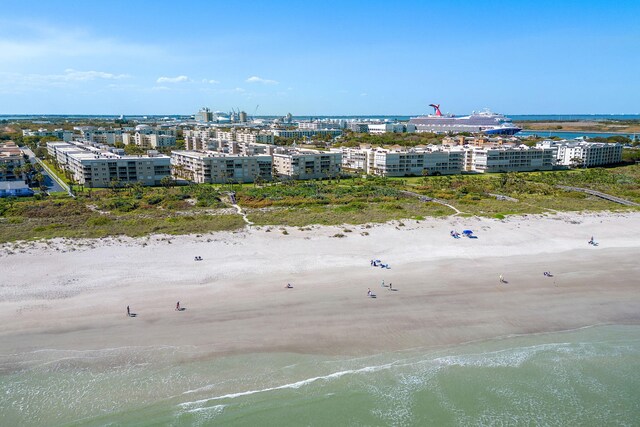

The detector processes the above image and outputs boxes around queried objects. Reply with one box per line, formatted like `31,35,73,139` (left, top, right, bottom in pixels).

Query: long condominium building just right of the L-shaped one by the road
171,150,272,184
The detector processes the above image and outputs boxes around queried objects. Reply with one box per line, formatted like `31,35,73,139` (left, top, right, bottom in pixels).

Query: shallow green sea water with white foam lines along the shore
0,326,640,426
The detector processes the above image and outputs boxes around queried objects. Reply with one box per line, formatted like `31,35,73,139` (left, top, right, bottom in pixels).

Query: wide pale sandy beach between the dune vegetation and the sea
0,213,640,362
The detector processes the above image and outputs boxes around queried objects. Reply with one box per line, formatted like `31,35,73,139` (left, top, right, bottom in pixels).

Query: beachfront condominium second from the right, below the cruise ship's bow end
465,145,557,173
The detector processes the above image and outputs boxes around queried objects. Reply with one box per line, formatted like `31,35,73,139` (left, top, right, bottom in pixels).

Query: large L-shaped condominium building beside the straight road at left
47,142,171,188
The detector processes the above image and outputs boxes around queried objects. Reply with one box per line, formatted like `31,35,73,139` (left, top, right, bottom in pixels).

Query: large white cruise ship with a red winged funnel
409,104,522,135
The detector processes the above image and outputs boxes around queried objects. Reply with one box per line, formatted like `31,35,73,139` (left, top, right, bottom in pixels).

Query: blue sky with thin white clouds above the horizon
0,0,640,116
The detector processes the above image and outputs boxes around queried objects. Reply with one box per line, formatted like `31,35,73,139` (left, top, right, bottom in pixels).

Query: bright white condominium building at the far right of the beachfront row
536,140,623,168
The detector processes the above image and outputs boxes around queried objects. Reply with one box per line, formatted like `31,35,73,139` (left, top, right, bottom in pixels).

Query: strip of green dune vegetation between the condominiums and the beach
0,165,640,242
